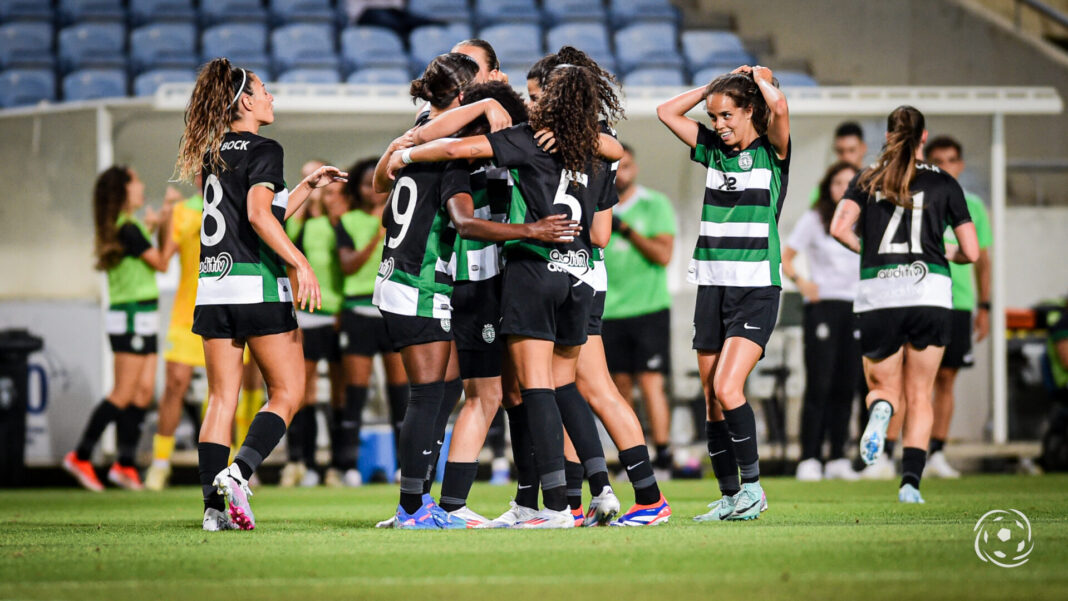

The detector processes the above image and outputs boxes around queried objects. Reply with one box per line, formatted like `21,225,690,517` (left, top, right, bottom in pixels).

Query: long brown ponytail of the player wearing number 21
858,105,926,208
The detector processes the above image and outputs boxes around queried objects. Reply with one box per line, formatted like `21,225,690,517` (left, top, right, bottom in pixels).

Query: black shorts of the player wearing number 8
193,302,297,341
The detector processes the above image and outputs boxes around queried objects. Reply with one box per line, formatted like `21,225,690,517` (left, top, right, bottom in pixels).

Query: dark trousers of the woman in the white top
801,300,862,460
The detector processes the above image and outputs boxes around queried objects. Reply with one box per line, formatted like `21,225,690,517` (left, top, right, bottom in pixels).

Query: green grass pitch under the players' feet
0,476,1068,601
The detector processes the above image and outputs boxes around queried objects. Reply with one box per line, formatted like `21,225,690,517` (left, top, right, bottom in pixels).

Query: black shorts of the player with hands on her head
693,286,782,352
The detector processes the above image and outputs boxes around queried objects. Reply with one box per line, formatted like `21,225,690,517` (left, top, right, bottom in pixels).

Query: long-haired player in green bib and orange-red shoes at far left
63,165,169,492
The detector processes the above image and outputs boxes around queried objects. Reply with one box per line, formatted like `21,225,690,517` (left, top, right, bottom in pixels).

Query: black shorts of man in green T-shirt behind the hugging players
603,309,671,375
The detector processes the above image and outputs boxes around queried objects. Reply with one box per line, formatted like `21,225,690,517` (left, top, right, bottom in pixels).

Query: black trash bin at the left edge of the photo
0,330,44,487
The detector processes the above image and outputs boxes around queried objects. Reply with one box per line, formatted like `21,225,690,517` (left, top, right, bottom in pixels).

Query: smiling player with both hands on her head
657,65,790,521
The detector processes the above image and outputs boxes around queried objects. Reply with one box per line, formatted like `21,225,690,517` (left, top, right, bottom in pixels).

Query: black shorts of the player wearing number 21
857,306,953,360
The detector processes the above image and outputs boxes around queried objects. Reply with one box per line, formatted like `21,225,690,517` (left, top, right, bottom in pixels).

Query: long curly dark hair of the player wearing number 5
530,65,601,177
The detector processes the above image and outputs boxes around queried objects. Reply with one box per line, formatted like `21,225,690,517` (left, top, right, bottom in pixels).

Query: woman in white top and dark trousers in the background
783,161,861,481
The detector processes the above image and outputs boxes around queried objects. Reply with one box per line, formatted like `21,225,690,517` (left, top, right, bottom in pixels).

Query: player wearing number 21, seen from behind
831,106,979,503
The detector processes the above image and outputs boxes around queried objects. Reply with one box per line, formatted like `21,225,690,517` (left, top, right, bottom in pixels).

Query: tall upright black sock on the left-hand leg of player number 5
522,389,567,511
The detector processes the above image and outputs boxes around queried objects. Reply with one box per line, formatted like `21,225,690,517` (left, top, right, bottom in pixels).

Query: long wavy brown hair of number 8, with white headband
174,59,253,181
